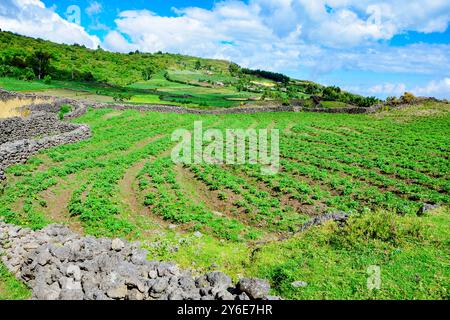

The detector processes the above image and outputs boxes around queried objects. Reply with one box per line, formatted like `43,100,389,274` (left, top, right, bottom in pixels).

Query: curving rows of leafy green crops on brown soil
0,105,450,240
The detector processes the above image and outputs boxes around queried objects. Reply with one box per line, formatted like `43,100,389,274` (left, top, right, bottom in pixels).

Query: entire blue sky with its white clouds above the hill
0,0,450,98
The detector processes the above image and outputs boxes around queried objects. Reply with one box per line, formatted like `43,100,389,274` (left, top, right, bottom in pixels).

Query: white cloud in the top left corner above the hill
0,0,100,48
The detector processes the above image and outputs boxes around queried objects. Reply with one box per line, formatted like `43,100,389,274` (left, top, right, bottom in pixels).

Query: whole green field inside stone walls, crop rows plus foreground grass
0,103,450,299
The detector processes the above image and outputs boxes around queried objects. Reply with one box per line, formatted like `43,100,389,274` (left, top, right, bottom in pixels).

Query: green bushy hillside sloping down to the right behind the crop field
0,32,378,108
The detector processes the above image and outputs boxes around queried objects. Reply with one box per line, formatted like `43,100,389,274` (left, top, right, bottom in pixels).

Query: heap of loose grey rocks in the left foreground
0,221,278,300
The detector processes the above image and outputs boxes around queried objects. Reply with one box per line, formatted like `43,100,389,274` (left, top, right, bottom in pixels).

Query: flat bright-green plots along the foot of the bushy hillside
0,74,255,108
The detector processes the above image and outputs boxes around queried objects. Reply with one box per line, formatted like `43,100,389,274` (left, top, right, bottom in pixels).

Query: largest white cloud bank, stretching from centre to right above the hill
105,0,450,77
